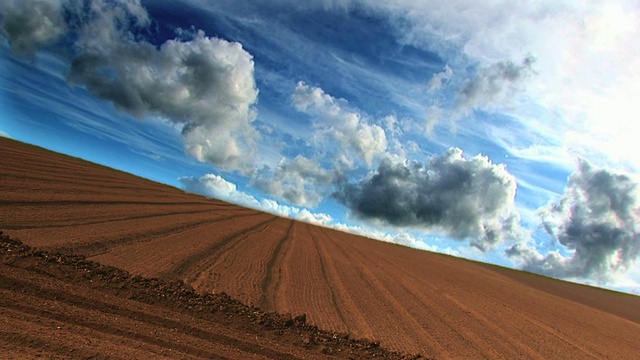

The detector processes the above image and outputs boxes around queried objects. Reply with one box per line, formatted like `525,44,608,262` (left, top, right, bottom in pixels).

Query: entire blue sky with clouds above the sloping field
0,0,640,294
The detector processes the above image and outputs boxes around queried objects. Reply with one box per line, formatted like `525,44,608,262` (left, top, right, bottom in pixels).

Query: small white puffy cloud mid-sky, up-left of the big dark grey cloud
292,82,387,167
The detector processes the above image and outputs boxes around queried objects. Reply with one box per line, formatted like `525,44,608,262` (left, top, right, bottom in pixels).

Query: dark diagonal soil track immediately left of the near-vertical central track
166,213,278,283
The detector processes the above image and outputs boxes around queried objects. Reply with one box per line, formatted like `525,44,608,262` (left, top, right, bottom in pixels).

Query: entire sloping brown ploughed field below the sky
0,139,640,359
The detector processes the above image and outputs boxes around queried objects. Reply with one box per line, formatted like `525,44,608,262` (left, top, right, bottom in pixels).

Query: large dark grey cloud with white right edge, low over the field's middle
334,148,519,250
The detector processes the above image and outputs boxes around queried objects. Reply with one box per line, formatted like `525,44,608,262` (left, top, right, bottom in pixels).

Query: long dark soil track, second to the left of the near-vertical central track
56,211,262,258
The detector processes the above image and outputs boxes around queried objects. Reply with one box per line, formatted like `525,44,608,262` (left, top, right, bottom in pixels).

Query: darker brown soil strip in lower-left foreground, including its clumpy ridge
0,233,417,359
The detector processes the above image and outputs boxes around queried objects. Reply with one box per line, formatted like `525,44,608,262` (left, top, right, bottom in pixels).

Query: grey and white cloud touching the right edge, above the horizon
507,161,640,281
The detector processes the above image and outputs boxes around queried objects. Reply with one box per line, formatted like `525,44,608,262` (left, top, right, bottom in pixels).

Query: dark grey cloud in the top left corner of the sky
0,0,67,55
